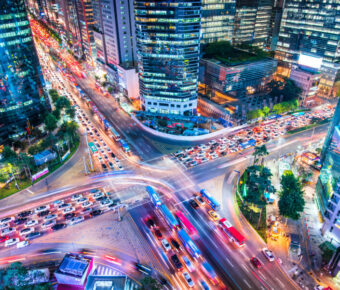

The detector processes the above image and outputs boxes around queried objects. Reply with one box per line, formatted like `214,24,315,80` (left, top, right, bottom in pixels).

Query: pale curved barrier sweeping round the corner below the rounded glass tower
131,114,249,143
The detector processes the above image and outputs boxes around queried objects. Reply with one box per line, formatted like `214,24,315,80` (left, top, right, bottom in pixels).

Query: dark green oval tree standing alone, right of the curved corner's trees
279,171,305,220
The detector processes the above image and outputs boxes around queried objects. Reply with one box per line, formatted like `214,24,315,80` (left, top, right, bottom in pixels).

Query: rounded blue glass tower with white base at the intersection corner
134,0,202,115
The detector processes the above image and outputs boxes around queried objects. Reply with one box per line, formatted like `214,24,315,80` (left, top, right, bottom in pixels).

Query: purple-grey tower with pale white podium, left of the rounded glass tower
93,0,139,99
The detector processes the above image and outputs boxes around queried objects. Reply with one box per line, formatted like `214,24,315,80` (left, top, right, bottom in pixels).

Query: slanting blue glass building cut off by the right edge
316,101,340,244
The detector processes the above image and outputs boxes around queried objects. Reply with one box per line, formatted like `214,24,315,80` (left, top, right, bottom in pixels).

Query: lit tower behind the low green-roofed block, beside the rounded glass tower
201,0,236,44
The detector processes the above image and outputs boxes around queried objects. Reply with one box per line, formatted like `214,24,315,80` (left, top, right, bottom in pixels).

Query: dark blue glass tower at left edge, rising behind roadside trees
0,0,46,144
